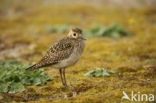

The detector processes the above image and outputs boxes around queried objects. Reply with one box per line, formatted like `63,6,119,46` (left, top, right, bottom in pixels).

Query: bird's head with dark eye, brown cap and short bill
67,28,86,40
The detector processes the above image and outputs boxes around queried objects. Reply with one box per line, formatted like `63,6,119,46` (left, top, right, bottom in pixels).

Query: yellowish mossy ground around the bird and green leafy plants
0,2,156,103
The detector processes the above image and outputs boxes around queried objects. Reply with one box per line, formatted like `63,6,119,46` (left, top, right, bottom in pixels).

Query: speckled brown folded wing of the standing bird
29,38,74,69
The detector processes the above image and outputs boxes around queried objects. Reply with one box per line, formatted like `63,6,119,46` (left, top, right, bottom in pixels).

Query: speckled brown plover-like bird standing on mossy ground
27,27,86,87
